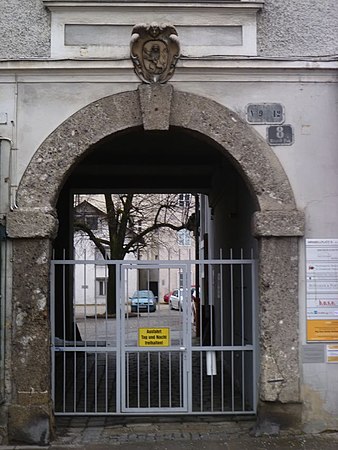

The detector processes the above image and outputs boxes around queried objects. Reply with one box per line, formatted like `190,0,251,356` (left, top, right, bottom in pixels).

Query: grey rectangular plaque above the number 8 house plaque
246,103,285,125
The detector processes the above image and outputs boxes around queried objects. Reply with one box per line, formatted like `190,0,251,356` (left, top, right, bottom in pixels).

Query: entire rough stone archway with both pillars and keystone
7,85,303,443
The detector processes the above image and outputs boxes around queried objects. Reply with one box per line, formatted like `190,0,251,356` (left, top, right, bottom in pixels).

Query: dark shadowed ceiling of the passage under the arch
67,129,232,193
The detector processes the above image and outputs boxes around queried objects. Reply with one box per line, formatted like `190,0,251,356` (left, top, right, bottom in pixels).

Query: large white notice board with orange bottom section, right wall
306,239,338,342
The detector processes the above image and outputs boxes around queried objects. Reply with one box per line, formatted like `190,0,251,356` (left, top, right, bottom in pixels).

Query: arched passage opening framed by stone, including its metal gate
51,128,257,415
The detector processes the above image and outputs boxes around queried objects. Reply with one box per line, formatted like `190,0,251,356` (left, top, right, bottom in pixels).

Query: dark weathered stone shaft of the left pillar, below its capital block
11,239,50,409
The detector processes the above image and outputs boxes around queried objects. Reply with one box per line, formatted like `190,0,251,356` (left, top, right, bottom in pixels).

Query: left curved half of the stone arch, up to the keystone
17,91,142,209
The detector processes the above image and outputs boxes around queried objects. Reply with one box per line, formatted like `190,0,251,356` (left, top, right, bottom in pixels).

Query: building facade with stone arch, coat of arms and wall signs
0,0,338,443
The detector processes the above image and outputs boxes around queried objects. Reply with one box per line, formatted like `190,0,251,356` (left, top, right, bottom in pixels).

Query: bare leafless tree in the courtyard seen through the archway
74,193,194,314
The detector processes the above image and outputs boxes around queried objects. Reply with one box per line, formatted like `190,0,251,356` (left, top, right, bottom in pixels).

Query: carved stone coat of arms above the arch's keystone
130,23,180,83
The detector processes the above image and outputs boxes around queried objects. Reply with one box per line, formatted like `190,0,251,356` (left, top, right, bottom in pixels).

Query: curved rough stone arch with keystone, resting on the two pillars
17,86,296,218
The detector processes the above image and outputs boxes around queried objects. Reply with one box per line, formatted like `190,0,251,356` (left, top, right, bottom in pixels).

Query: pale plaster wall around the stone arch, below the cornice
0,61,338,428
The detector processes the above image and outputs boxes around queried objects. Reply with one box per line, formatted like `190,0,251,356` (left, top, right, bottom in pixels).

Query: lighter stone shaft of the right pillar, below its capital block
259,237,300,403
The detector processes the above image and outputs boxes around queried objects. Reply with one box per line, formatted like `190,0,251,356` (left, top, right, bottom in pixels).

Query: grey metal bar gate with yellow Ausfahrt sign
51,259,257,415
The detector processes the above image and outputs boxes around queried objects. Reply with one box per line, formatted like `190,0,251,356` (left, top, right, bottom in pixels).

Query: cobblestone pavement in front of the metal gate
0,417,338,450
